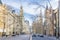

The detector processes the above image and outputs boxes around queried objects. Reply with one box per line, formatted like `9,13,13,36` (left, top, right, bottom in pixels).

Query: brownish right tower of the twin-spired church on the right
49,6,54,36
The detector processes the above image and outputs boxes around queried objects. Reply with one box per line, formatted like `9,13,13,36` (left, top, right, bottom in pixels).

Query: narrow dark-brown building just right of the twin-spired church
53,8,59,36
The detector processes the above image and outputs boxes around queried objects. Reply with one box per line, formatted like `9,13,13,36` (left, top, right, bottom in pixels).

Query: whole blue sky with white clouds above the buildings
1,0,58,24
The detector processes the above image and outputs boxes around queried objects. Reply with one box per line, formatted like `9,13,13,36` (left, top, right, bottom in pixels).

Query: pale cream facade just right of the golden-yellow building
5,11,15,35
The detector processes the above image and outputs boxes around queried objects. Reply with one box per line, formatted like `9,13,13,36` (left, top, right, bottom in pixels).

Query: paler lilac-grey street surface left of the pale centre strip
0,35,29,40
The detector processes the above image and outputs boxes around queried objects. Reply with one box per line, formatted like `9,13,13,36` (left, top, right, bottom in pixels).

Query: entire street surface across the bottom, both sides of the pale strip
0,35,60,40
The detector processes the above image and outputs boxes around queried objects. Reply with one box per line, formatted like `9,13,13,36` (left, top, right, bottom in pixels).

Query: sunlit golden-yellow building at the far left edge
0,0,13,36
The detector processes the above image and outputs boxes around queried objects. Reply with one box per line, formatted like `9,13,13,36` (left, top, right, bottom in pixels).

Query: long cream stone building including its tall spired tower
6,6,28,35
